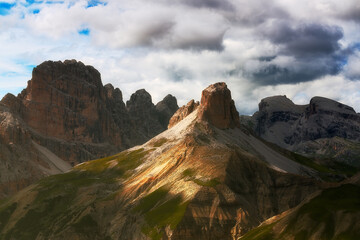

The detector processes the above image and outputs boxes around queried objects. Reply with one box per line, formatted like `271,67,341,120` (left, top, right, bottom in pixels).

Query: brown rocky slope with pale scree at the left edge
0,103,71,198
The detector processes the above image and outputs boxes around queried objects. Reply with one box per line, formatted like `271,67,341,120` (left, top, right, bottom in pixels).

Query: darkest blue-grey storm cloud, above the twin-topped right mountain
240,22,348,85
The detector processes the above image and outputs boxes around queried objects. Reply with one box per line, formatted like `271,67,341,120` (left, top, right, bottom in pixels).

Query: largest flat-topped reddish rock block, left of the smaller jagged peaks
20,60,122,146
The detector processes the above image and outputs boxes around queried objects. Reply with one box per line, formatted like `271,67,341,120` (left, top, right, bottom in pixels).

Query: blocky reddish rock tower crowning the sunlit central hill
198,82,240,129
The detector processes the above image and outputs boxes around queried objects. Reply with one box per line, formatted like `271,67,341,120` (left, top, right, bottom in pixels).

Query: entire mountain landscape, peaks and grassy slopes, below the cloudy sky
0,61,360,240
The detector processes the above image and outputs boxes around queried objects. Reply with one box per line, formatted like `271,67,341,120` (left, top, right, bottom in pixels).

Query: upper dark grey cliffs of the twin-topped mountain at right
253,96,360,146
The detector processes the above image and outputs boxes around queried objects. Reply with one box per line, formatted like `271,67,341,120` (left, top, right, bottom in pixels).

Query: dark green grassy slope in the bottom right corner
240,175,360,240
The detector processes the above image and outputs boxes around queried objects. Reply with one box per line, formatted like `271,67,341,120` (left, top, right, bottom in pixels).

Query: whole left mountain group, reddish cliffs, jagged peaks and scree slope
0,60,178,196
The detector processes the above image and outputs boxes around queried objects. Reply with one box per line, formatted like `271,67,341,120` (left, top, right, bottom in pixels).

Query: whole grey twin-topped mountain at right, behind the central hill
250,96,360,167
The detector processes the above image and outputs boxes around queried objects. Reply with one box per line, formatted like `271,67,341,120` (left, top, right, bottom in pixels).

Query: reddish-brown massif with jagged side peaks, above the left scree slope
2,60,177,163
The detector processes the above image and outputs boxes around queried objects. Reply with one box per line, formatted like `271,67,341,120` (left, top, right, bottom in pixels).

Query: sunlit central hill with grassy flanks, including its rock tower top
0,83,325,239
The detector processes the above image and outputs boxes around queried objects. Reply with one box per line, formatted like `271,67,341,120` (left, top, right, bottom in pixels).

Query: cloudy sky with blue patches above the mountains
0,0,360,115
